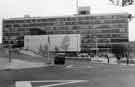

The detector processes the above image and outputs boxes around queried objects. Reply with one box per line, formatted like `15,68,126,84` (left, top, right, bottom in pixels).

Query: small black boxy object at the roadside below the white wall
54,54,65,65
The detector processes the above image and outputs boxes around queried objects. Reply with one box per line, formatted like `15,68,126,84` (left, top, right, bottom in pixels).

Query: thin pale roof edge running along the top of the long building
3,12,128,20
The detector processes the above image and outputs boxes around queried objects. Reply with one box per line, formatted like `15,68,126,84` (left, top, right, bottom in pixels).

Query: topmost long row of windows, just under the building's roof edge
3,20,128,28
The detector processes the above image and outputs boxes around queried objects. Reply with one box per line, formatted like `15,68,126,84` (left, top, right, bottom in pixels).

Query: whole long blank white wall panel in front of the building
24,34,81,52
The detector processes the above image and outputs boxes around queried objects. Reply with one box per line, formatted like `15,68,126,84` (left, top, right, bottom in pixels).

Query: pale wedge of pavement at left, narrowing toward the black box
0,58,48,70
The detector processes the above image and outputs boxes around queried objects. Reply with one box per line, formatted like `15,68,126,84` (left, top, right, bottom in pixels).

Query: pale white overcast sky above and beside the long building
0,0,135,41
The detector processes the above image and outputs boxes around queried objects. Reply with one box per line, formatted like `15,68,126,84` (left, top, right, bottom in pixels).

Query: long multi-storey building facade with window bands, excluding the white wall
2,13,129,52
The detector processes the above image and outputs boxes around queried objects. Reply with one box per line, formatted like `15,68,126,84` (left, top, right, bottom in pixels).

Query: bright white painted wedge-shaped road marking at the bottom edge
16,80,88,87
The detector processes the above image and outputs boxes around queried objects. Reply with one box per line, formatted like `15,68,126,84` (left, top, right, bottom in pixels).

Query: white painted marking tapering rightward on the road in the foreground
16,80,88,87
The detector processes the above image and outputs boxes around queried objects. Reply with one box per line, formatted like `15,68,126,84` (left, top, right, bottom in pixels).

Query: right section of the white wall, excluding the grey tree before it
50,34,80,51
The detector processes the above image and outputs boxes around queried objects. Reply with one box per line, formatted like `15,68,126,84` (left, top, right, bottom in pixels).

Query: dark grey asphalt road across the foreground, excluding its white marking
0,64,135,87
